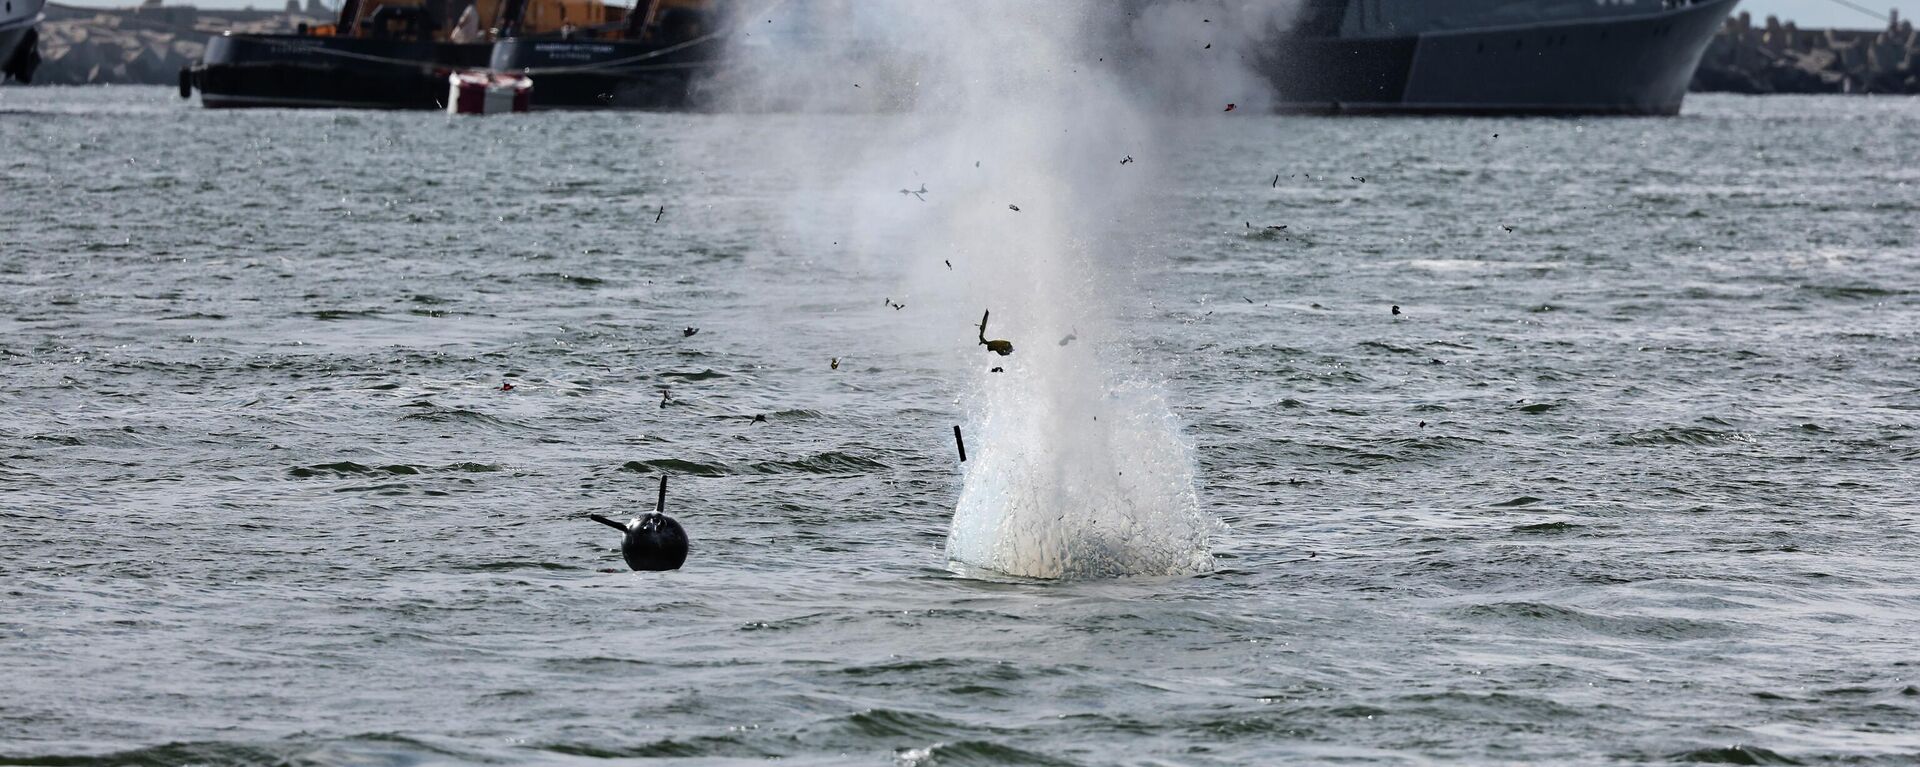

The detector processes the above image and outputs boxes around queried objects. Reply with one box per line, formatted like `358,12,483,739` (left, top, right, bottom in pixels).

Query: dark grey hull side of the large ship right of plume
1261,0,1736,115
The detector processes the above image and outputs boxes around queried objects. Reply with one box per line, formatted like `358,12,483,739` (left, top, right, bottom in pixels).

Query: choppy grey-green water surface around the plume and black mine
0,88,1920,765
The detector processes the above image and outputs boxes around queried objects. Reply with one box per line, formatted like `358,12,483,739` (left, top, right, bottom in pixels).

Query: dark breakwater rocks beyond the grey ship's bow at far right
1692,12,1920,94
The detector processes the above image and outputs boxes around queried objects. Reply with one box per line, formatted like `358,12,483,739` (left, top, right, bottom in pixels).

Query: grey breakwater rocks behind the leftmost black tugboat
33,4,330,85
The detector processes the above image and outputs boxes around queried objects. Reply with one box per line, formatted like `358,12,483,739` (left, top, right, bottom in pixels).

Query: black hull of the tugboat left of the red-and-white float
192,35,492,110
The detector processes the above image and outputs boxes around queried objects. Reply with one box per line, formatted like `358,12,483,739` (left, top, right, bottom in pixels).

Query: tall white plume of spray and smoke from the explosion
698,0,1297,579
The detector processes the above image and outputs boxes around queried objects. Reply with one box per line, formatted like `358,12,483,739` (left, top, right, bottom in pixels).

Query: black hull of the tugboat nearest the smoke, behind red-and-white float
492,38,714,110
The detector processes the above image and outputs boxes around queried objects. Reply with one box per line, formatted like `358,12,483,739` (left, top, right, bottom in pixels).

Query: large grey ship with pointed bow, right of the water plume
1260,0,1736,115
